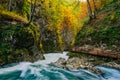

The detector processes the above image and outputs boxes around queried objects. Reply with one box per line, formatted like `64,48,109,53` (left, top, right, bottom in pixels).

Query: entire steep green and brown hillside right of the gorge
75,0,120,53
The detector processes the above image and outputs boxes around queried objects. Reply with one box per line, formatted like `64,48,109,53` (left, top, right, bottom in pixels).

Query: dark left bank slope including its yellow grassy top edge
0,10,43,65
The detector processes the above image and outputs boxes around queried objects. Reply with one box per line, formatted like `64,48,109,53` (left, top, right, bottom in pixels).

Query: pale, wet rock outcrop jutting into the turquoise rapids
51,57,101,74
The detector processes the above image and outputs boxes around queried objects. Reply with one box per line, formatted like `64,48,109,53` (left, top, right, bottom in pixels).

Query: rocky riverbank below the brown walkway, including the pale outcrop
50,53,120,74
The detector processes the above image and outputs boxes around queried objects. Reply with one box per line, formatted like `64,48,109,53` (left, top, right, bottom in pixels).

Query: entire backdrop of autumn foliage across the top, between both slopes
0,0,110,49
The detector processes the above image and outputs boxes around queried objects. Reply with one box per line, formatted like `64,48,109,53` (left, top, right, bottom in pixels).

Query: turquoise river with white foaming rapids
0,52,120,80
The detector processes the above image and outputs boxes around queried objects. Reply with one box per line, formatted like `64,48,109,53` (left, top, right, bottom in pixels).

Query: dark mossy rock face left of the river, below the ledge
0,23,44,65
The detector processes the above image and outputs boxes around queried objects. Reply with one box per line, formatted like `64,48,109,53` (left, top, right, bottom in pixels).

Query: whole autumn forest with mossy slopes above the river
0,0,120,80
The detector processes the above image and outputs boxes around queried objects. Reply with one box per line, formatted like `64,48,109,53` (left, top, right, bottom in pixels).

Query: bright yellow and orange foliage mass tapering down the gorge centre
40,0,85,48
